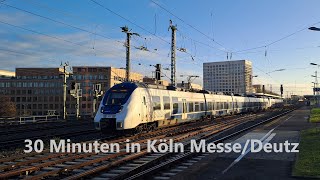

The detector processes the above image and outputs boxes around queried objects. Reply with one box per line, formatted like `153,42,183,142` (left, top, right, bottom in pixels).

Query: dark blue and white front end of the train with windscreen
94,82,137,133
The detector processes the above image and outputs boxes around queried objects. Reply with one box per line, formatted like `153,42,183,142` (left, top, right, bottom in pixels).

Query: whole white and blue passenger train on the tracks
94,82,282,132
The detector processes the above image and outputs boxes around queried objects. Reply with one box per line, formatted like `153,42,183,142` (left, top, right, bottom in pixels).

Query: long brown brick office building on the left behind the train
0,66,142,116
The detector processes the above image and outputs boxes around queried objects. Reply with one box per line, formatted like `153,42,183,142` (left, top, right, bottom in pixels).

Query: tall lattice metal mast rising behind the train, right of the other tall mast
170,20,177,86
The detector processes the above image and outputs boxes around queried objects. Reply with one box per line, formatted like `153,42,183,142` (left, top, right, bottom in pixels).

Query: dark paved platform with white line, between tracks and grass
173,107,315,180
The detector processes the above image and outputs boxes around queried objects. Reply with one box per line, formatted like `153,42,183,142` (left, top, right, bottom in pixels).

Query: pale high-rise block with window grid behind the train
203,60,252,94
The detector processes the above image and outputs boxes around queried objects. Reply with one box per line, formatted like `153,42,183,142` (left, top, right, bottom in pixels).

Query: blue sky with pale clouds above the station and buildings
0,0,320,95
